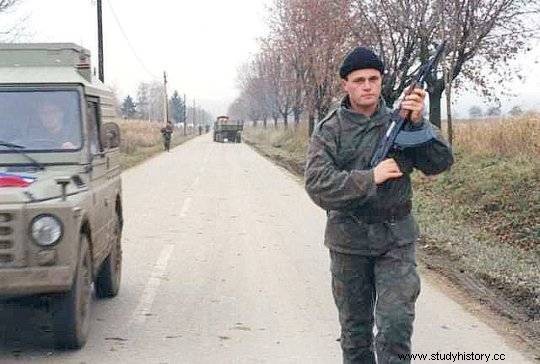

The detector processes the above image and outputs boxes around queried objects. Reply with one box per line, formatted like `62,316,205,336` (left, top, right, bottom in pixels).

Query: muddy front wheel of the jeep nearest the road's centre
52,234,92,349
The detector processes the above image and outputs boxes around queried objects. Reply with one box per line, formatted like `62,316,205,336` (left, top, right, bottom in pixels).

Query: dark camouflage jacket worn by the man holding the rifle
305,97,453,256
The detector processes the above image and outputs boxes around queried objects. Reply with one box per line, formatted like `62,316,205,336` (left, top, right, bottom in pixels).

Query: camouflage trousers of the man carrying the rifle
330,244,420,364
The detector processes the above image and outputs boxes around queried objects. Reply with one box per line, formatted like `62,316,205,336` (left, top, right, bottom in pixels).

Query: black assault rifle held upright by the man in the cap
370,41,446,168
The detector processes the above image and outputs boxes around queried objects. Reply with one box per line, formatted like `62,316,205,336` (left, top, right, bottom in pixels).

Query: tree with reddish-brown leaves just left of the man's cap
270,0,352,133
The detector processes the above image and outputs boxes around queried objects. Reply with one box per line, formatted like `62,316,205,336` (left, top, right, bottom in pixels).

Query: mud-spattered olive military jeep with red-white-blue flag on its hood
0,44,123,348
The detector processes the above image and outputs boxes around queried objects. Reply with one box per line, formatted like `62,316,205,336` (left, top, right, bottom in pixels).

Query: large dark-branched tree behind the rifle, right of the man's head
353,0,539,127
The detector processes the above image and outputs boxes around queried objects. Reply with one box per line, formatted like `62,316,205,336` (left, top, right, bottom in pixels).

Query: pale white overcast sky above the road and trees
2,0,540,116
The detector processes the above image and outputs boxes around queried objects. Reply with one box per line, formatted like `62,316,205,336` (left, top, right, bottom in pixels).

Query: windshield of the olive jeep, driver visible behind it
0,90,82,153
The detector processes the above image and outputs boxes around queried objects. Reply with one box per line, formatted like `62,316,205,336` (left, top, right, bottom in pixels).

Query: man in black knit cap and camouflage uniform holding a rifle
305,47,453,364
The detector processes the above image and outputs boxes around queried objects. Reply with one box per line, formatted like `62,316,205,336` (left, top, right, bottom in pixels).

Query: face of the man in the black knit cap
342,68,382,108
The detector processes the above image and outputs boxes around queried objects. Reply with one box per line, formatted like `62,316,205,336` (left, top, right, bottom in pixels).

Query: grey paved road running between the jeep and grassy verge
0,136,527,364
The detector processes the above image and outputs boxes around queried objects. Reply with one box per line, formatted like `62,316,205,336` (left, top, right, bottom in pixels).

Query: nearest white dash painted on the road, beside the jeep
131,244,174,324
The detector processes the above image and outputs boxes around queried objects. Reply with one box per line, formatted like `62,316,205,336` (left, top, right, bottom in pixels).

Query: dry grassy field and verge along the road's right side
245,114,540,341
